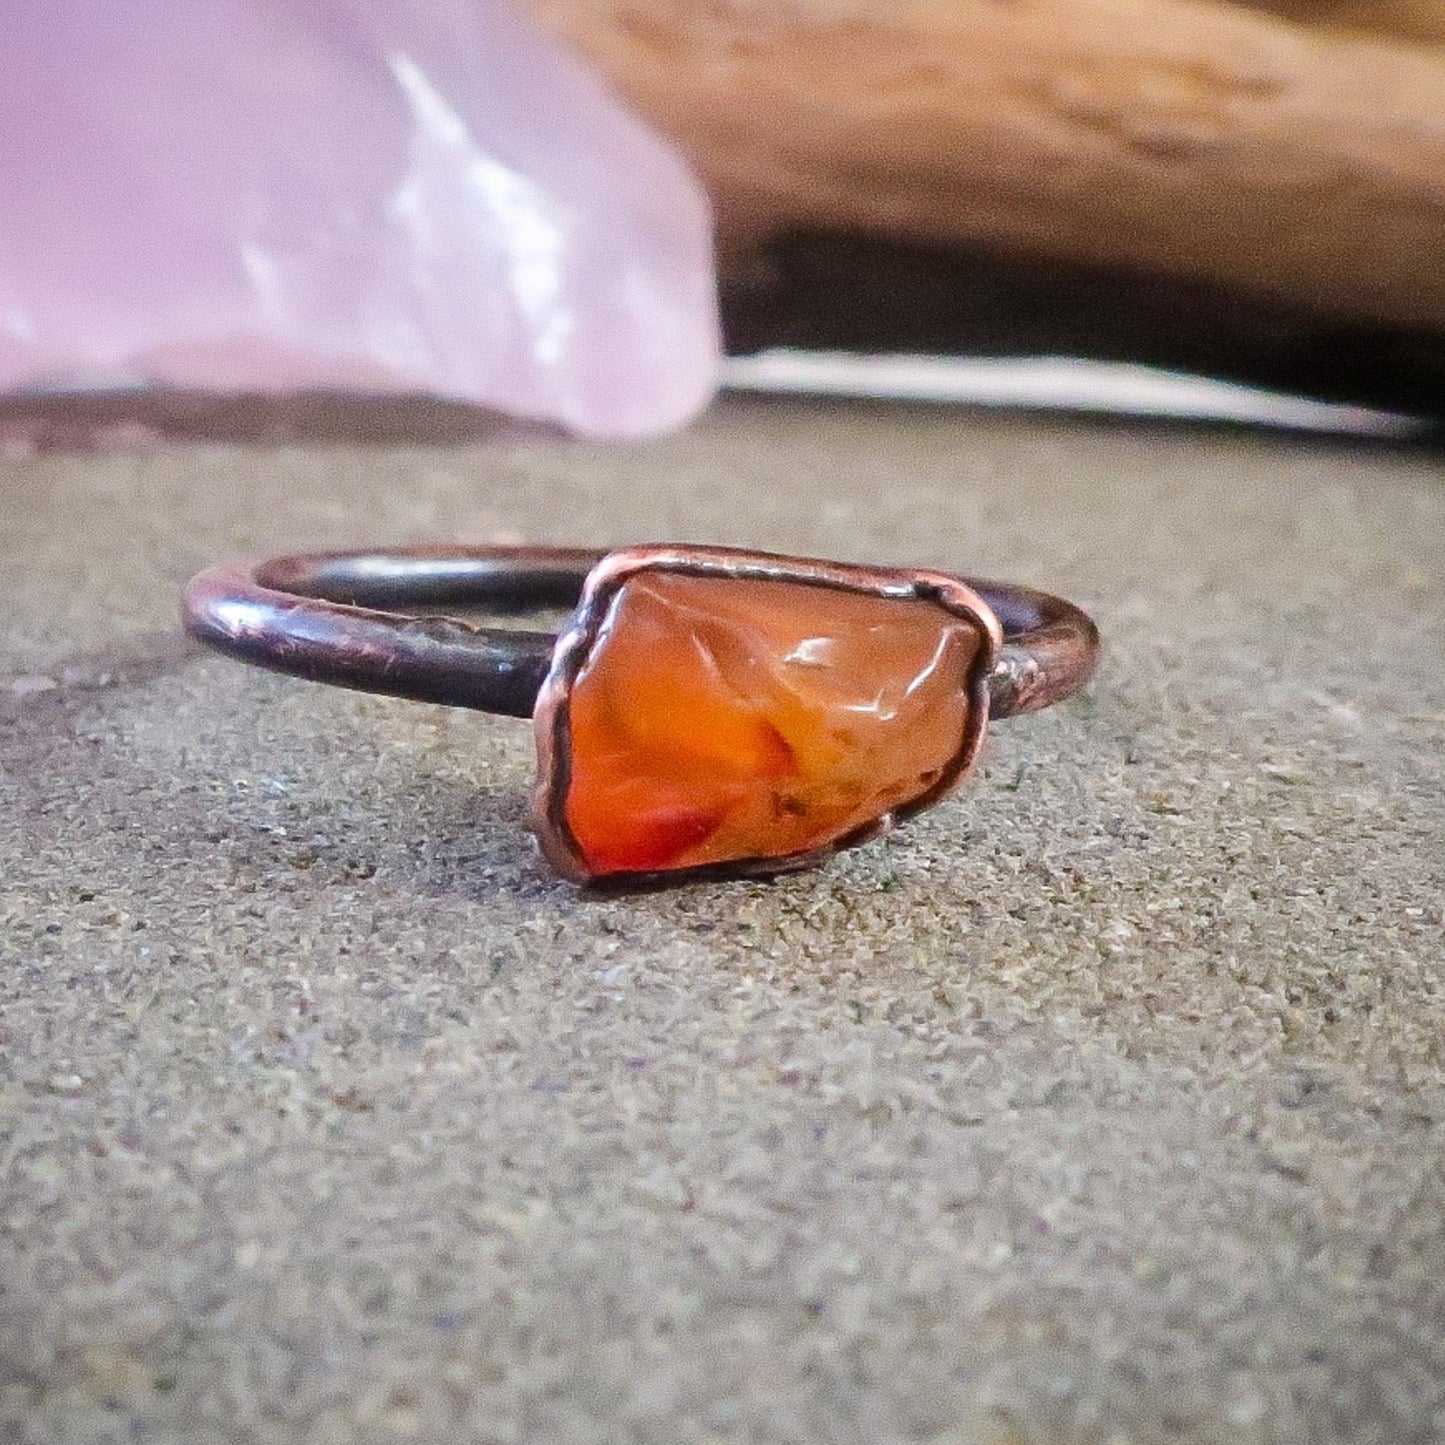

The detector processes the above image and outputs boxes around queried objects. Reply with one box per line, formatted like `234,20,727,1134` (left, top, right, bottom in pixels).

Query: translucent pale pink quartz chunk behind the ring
0,0,718,436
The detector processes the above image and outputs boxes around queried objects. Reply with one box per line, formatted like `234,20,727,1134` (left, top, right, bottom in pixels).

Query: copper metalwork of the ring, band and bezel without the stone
184,545,1098,881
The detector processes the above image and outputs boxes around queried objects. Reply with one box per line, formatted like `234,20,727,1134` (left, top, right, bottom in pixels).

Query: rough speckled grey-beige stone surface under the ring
0,405,1445,1445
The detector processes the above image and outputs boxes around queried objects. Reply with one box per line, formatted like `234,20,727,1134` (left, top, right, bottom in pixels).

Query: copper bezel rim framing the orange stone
533,545,1003,884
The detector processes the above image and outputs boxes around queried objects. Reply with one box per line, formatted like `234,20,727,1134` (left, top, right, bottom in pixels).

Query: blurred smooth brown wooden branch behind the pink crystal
529,0,1445,329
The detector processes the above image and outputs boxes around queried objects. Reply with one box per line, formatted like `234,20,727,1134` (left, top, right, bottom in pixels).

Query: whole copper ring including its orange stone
184,545,1098,883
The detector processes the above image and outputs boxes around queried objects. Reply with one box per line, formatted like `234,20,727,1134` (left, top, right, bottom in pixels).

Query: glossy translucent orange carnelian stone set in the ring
564,571,984,876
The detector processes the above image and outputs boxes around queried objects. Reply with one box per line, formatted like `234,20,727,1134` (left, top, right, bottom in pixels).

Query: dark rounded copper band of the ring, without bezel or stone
177,545,1098,720
